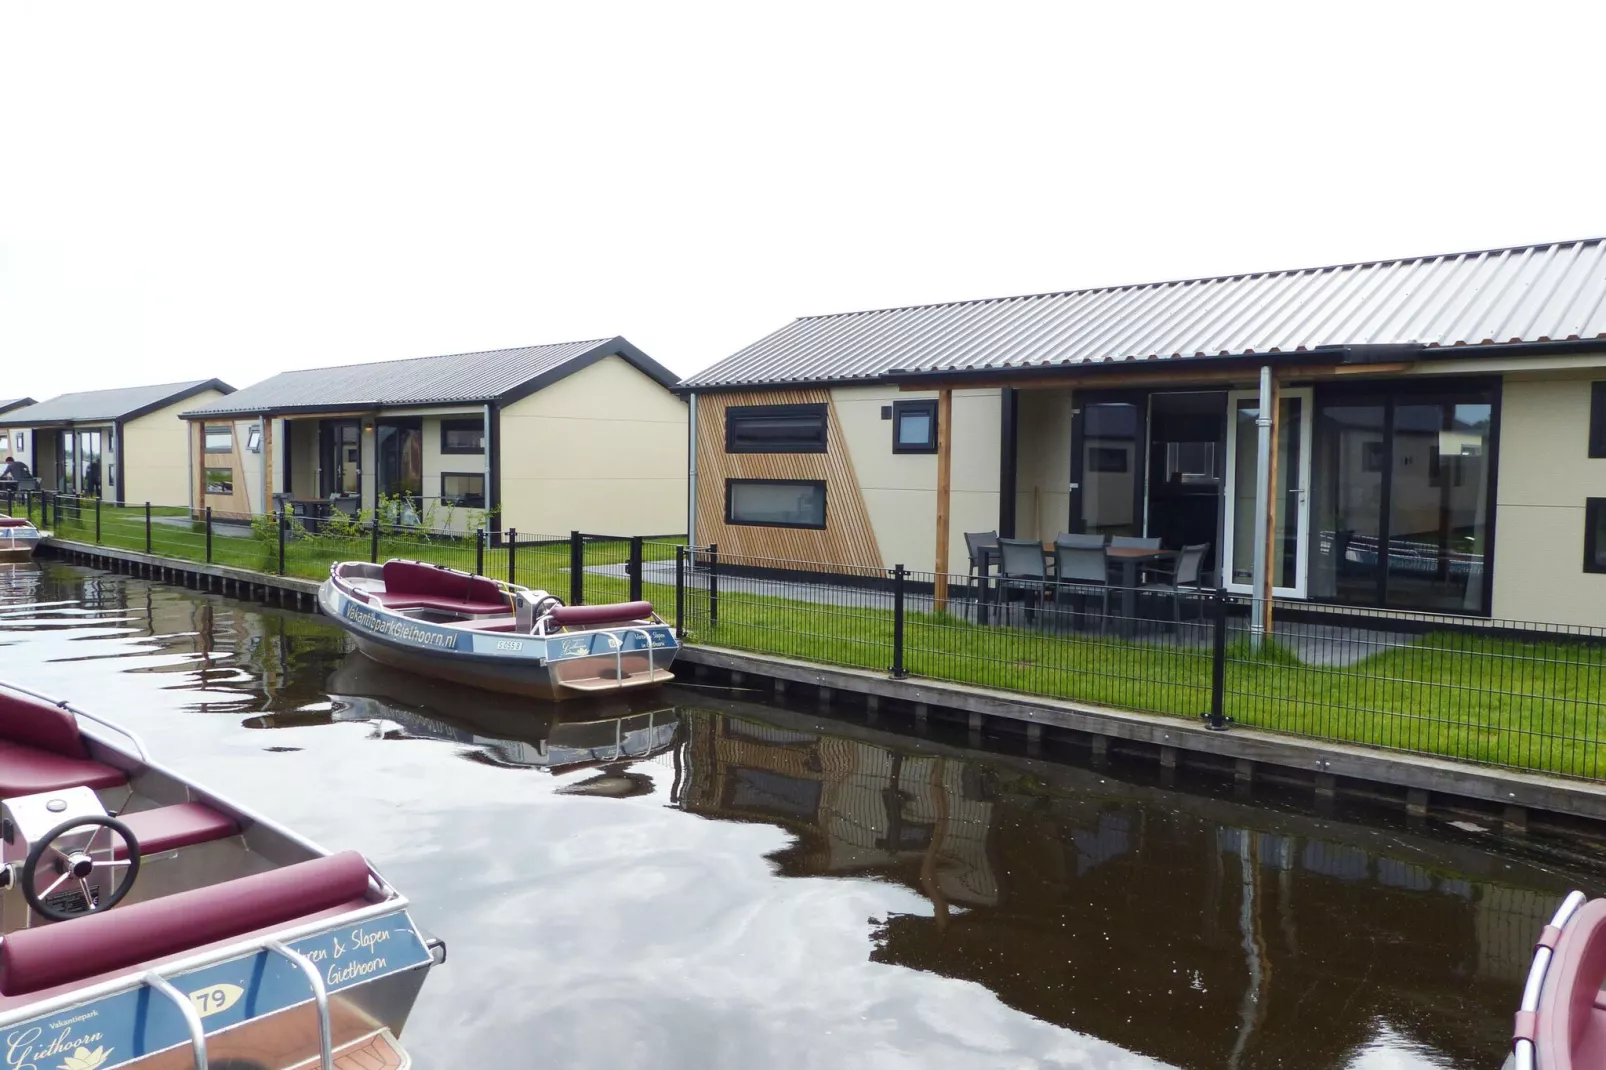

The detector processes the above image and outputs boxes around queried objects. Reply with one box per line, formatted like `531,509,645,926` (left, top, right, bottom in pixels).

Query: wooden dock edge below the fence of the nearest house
679,644,1606,832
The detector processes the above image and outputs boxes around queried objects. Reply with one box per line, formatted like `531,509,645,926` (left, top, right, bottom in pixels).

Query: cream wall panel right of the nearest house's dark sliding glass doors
1494,370,1606,627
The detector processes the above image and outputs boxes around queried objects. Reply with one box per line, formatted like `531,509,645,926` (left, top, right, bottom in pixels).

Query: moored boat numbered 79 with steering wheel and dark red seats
0,684,445,1070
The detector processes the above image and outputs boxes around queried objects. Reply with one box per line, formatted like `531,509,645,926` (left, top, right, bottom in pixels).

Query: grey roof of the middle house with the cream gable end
185,337,675,416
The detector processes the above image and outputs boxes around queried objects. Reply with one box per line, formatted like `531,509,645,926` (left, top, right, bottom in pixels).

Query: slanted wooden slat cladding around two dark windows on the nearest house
697,383,882,569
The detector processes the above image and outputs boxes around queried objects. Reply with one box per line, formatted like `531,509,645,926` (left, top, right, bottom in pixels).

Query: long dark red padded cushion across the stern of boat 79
0,852,368,996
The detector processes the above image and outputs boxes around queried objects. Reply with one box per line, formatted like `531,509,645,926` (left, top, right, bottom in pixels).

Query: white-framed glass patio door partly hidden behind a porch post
1222,387,1312,598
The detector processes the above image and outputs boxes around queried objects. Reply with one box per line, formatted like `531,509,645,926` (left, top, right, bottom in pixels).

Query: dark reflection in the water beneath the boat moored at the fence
246,652,681,797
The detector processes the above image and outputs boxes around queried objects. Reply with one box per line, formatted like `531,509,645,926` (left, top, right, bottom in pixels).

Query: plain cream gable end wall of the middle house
494,357,687,535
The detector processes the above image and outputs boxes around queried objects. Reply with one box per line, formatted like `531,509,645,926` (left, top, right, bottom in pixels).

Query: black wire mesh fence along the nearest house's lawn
676,546,1606,778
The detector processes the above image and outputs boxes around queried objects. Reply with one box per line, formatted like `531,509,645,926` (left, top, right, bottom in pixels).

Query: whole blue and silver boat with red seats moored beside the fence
318,559,679,699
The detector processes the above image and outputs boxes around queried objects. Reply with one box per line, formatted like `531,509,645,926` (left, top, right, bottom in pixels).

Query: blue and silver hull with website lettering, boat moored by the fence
318,580,679,702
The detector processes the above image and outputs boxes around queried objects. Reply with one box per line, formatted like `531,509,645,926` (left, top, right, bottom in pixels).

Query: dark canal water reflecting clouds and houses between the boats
0,562,1606,1070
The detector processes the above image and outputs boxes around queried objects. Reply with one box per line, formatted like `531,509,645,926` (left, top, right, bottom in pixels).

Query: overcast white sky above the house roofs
0,0,1606,398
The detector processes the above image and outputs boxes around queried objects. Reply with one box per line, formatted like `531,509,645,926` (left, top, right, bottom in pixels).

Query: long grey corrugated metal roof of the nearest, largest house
683,238,1606,387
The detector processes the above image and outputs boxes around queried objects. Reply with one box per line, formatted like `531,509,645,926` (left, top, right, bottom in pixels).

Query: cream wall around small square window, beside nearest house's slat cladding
835,386,999,574
